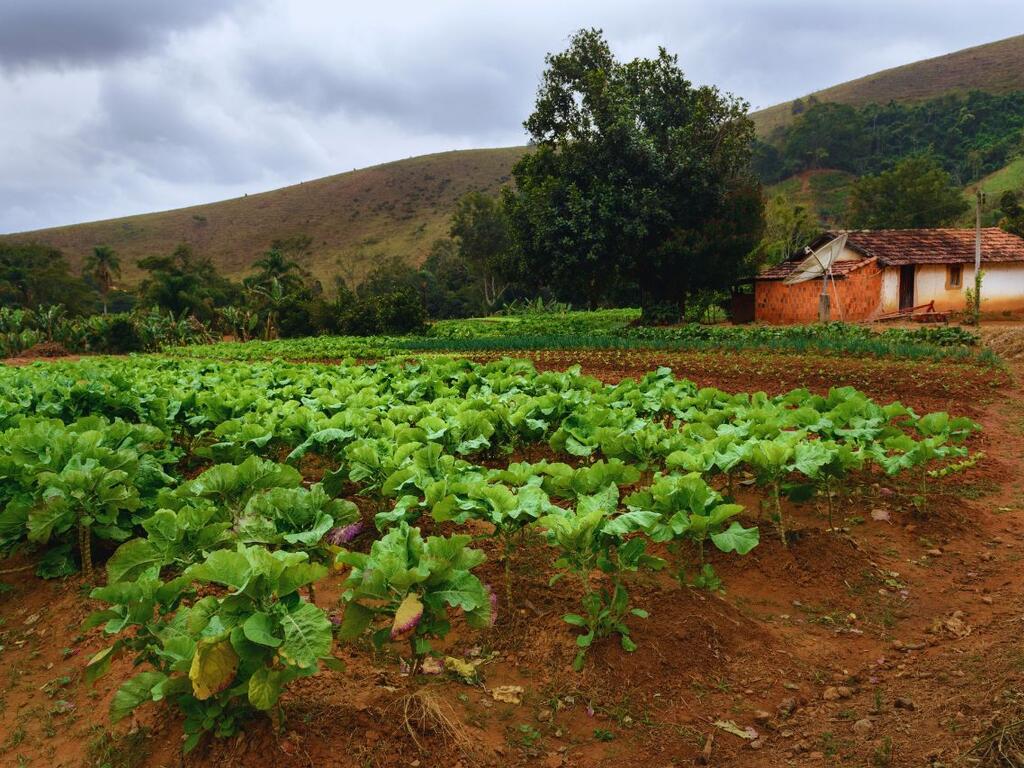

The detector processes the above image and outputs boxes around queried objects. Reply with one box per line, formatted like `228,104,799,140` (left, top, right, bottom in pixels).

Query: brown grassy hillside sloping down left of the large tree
4,146,524,284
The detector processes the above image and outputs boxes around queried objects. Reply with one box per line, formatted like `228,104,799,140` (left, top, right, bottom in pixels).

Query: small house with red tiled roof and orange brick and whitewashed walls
754,227,1024,324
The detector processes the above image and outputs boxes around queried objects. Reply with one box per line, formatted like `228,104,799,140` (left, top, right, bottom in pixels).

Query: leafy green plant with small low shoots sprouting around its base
538,485,665,672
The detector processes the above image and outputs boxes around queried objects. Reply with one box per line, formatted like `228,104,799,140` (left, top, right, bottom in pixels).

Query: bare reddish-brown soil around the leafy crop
0,353,1024,768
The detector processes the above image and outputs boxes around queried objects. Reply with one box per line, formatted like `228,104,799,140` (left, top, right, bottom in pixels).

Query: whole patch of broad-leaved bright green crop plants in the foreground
0,357,977,745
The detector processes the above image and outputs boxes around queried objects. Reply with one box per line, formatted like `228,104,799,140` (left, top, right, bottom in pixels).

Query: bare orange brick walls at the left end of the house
754,261,882,325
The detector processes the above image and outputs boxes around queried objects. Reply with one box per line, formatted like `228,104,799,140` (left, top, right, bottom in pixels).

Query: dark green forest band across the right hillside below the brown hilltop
753,91,1024,185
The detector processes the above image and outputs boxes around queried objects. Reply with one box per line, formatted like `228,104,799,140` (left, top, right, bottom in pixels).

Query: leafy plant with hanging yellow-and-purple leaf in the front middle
336,522,495,674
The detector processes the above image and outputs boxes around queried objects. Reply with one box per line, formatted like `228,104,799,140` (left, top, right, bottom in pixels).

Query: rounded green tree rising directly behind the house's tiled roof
848,155,968,229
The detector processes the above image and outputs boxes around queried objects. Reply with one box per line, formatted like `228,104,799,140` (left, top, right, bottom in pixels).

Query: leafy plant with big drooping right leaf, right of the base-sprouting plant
625,472,760,588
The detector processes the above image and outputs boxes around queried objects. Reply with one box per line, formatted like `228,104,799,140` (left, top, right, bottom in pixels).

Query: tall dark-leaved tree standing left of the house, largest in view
506,30,762,310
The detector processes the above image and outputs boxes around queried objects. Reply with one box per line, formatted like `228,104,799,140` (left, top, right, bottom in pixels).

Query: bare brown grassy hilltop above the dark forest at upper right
752,35,1024,136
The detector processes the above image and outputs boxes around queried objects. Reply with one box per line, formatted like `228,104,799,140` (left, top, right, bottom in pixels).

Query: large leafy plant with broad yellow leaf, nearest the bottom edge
86,545,340,752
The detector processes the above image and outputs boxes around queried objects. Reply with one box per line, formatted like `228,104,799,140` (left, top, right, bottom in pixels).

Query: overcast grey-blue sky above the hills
0,0,1024,232
